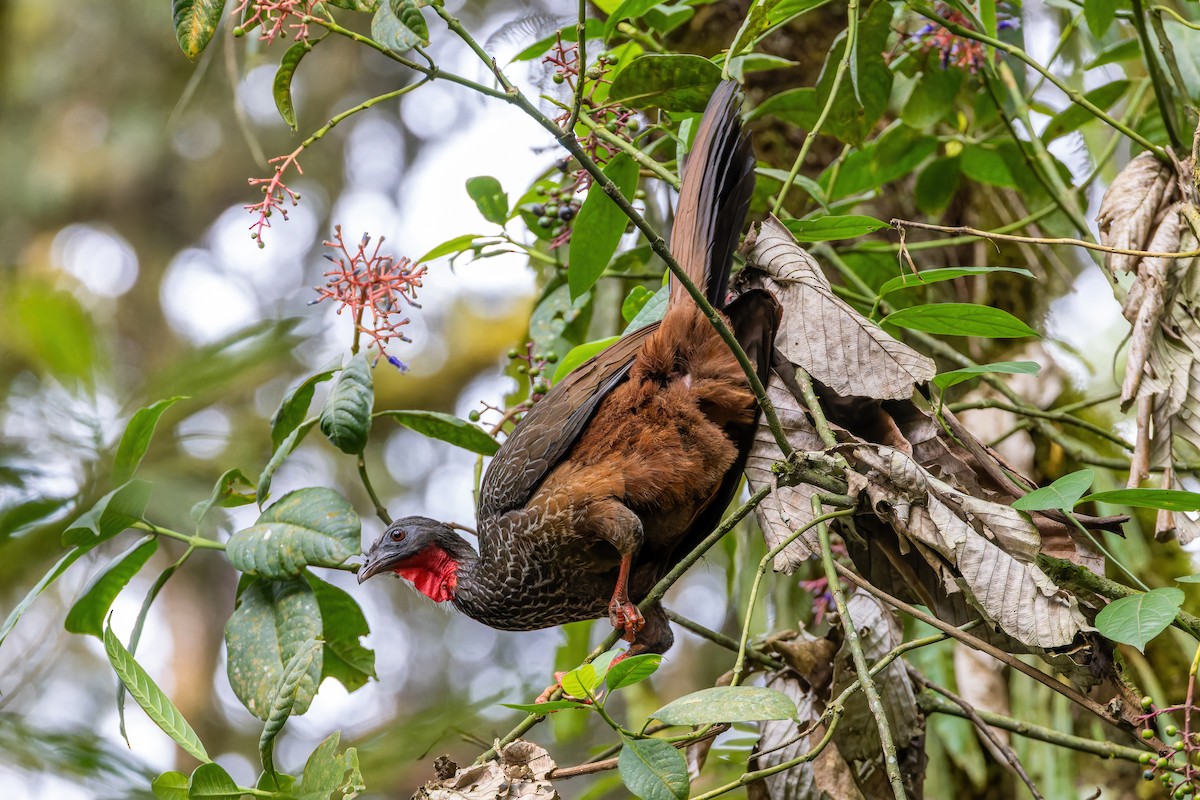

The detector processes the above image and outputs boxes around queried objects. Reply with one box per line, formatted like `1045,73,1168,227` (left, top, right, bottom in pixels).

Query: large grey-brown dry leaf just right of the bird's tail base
749,216,937,399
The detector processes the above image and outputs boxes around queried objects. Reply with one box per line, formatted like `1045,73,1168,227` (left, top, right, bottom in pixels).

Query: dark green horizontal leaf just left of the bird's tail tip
608,53,721,112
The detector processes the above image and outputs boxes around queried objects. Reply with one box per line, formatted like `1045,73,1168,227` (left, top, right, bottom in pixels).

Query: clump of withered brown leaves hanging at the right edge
1097,152,1200,543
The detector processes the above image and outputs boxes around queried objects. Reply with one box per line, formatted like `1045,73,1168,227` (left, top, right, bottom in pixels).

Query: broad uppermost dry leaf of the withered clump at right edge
1096,152,1172,275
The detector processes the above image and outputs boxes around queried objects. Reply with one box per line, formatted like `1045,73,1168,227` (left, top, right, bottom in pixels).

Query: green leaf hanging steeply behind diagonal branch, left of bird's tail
566,152,637,300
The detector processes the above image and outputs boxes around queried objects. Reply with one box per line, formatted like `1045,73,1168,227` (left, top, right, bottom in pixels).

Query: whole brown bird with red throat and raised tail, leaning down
358,82,781,656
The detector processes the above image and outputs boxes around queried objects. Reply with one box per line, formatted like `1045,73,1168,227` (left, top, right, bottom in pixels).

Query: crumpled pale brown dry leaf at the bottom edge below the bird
413,739,559,800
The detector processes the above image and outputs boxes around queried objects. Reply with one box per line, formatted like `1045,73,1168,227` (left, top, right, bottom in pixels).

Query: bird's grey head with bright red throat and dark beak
359,517,475,602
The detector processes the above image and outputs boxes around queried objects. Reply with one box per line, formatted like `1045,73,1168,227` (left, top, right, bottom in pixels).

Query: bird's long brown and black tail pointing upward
668,80,755,308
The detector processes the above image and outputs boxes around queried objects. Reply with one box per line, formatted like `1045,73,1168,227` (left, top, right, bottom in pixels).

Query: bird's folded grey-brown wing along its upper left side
478,323,659,519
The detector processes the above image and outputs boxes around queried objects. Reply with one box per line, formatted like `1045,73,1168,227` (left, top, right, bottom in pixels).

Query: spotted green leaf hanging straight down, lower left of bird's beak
224,579,322,720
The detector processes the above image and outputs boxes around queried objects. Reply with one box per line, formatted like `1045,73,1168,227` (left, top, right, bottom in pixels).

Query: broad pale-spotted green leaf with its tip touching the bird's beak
226,487,361,579
